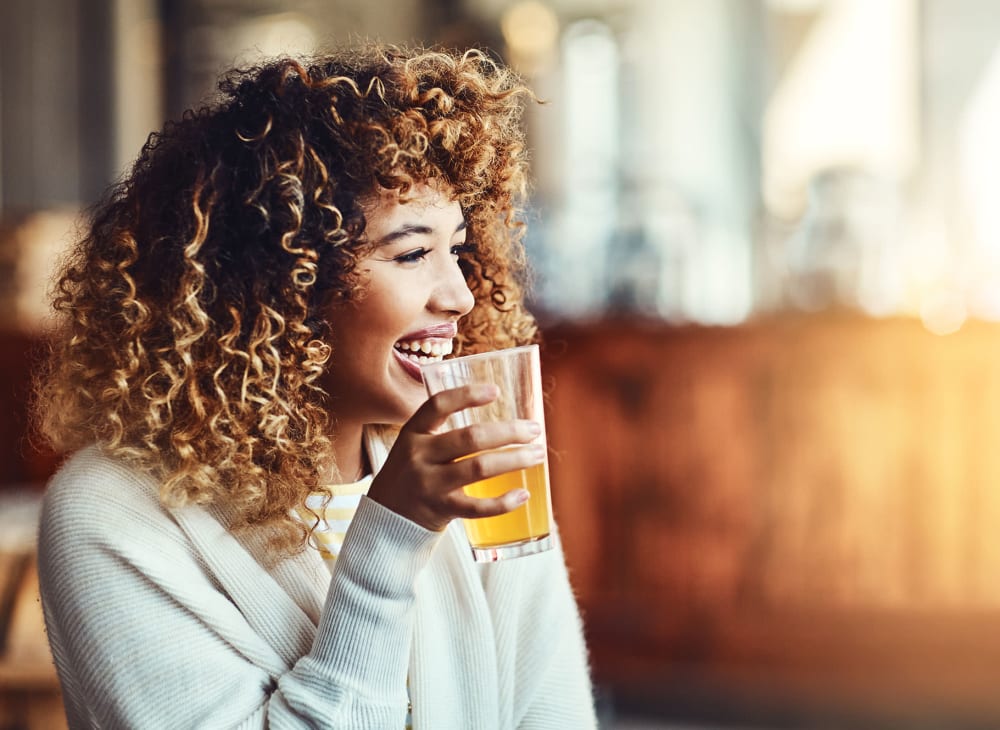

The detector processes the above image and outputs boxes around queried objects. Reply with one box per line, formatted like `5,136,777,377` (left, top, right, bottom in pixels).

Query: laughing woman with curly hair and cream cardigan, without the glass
38,42,595,730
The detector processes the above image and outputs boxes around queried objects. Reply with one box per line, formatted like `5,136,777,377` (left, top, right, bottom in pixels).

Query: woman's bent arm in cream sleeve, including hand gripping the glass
40,386,540,730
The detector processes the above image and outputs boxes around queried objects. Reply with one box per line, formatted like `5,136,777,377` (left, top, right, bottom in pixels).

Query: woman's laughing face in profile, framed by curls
325,185,475,428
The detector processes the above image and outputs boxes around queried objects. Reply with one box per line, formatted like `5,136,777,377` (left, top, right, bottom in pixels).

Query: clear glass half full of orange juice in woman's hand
421,345,552,562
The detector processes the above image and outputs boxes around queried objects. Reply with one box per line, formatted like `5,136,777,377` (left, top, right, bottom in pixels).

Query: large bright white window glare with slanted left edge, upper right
763,0,918,217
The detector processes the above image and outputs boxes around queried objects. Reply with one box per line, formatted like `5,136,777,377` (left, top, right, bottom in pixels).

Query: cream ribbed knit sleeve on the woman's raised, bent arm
39,450,437,730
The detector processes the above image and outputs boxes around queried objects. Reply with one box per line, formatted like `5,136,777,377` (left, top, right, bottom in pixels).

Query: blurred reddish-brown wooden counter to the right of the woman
543,317,1000,727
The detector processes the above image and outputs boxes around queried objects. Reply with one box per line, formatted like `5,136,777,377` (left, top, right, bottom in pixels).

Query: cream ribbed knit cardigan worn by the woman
39,432,596,730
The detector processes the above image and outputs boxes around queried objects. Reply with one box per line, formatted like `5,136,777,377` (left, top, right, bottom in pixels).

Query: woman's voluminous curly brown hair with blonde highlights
36,45,536,551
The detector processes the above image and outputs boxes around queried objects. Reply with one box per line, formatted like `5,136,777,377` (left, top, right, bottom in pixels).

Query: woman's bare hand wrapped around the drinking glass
368,384,545,531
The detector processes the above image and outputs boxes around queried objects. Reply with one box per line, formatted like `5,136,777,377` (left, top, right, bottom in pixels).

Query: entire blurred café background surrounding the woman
0,0,1000,730
